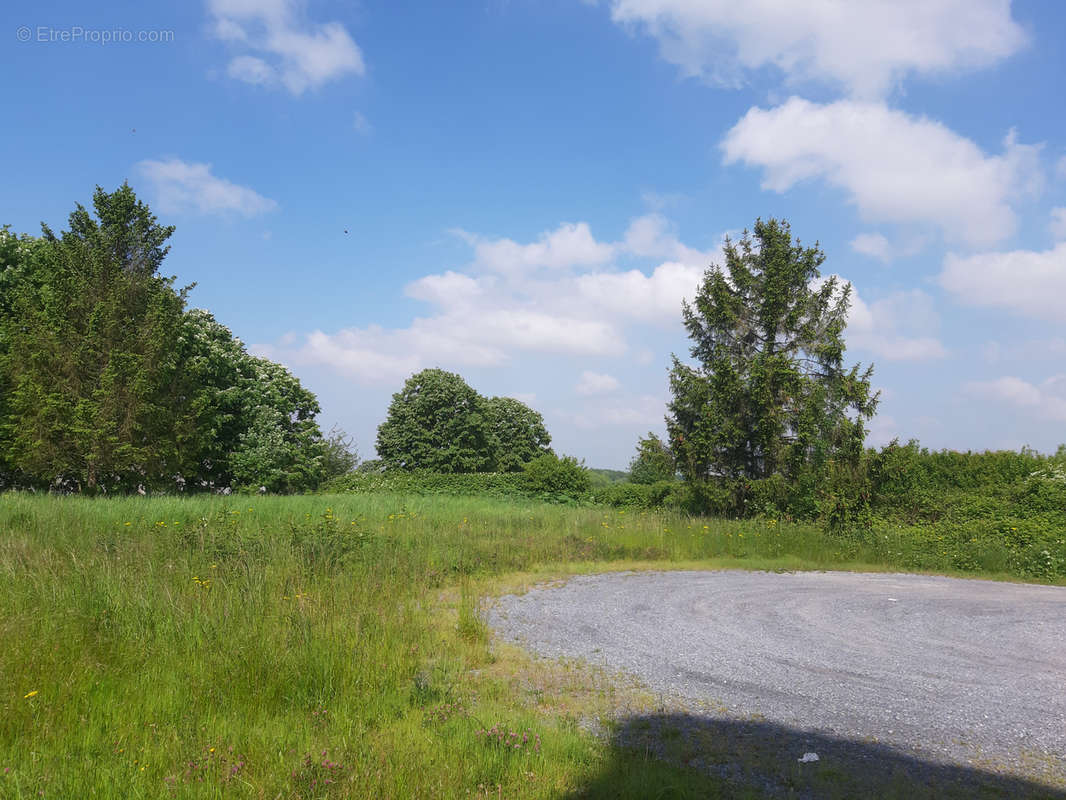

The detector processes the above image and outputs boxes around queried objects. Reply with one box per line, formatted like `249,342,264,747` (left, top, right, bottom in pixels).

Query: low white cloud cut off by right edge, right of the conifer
939,242,1066,322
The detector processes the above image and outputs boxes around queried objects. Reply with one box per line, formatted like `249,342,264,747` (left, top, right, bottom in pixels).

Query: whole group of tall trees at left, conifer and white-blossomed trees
0,183,354,493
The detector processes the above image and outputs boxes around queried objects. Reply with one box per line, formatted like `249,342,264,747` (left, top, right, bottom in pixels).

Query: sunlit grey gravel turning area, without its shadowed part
488,571,1066,783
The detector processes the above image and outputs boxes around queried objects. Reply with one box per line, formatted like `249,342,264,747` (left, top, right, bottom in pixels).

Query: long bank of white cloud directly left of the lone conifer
260,215,710,381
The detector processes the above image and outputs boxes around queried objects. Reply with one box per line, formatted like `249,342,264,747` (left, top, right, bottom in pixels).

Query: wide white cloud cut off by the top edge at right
611,0,1025,97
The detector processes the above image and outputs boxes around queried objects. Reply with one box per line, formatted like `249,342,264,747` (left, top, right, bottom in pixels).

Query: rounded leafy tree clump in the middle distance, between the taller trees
377,369,551,473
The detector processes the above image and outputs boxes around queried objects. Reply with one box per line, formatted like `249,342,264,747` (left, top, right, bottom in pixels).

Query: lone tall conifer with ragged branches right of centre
667,220,876,518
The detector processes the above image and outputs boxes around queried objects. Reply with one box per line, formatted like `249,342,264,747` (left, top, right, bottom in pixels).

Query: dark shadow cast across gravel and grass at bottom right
570,714,1066,800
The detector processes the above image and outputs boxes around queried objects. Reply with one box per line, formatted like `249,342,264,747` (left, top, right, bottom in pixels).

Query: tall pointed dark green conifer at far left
2,185,193,492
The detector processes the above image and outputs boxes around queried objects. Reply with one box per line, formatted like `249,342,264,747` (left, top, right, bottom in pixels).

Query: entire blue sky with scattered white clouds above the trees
0,0,1066,468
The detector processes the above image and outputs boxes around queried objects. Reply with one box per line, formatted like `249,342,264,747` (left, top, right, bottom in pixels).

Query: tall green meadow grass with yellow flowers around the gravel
0,494,1061,798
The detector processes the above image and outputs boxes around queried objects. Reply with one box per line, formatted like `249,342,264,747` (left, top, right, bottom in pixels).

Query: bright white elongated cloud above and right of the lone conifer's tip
722,97,1040,245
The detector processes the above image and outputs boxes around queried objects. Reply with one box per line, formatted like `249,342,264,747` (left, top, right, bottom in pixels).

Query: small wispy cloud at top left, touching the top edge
208,0,367,95
